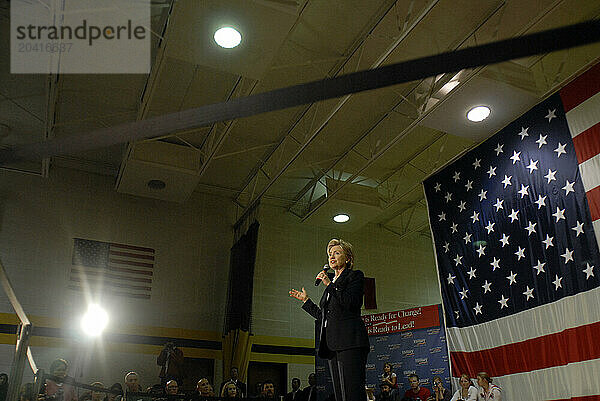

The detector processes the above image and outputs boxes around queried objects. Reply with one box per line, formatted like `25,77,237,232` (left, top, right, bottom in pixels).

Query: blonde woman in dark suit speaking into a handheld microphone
290,239,369,401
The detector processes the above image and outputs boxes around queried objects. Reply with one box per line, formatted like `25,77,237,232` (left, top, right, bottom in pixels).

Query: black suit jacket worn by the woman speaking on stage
302,269,369,359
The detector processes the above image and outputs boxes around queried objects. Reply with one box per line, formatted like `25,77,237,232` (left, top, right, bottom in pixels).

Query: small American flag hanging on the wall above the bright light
69,238,154,299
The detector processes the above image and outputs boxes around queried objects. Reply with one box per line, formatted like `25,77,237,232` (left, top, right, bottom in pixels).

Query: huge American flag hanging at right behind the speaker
424,65,600,401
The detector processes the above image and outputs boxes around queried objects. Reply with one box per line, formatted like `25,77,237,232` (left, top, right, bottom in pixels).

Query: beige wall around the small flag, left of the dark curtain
0,165,234,385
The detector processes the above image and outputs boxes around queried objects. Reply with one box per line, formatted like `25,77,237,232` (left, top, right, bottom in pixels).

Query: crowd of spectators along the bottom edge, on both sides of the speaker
5,359,502,401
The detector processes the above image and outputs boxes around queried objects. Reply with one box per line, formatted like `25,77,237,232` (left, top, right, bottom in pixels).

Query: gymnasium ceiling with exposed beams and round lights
0,0,600,237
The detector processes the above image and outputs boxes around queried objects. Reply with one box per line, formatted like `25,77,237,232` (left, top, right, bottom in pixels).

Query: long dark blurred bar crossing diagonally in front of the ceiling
0,20,600,163
